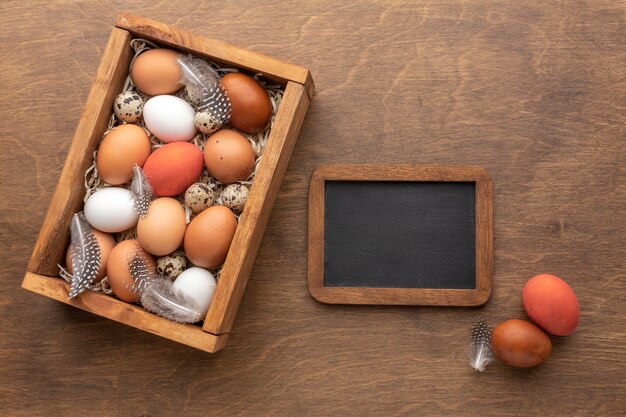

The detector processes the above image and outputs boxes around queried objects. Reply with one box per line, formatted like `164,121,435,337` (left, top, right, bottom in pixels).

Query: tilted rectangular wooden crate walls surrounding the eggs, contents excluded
22,13,314,352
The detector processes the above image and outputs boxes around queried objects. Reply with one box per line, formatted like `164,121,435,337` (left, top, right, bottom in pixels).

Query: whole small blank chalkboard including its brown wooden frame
309,165,493,305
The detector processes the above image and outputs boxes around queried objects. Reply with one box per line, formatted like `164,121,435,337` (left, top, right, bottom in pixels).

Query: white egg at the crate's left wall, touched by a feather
84,187,139,233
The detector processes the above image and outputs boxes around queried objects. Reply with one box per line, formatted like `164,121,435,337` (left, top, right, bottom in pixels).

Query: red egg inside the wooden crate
143,142,203,197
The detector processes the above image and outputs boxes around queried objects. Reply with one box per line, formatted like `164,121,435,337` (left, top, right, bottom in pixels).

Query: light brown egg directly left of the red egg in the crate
96,124,150,185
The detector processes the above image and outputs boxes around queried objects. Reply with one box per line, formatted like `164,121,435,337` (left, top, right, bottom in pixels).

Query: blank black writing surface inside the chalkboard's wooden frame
324,181,476,289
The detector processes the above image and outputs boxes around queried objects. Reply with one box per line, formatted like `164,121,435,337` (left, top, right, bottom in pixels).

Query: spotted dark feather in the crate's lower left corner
69,213,100,298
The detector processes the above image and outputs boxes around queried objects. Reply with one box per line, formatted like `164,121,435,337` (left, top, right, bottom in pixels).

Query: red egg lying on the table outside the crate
522,274,580,336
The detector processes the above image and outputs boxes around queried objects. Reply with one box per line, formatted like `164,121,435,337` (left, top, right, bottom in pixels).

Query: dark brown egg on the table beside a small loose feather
491,320,552,368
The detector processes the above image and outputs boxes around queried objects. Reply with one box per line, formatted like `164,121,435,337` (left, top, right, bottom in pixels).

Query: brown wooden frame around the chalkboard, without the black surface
308,164,493,306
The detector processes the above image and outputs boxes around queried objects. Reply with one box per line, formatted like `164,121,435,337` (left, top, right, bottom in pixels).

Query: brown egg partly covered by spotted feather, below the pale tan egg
107,240,156,303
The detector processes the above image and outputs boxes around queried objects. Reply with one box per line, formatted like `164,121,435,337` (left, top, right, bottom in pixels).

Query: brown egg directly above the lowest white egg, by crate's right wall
185,206,237,268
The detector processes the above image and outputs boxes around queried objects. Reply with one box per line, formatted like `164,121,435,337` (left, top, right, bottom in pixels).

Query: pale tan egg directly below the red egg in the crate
137,197,187,256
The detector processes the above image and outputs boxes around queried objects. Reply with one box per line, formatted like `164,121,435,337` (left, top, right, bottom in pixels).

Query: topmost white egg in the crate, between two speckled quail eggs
143,95,196,143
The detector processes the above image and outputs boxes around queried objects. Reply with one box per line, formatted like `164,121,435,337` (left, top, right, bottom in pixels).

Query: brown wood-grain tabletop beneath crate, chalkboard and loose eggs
0,0,626,416
